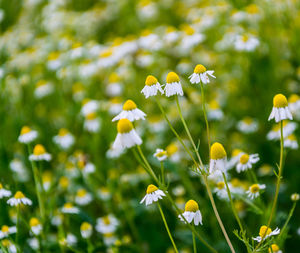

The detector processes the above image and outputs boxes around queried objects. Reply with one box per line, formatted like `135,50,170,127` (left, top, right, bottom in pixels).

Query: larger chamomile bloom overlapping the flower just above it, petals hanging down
113,119,142,149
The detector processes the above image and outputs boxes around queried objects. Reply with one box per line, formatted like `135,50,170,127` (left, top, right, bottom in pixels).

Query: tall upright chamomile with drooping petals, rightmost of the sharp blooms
268,94,293,122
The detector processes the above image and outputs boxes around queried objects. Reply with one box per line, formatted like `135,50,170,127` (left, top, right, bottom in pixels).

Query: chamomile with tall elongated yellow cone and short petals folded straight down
209,142,227,173
